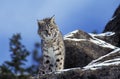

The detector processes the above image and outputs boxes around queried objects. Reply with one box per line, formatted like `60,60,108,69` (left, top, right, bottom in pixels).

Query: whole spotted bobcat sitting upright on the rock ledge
38,17,65,76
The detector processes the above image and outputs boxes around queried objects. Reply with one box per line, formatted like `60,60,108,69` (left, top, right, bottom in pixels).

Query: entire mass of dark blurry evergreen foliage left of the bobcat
0,34,40,79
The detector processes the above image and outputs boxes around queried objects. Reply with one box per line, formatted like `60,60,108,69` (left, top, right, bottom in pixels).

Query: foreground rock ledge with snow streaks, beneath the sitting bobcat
38,48,120,79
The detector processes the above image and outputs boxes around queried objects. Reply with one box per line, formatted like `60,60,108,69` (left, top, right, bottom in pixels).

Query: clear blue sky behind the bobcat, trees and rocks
0,0,120,64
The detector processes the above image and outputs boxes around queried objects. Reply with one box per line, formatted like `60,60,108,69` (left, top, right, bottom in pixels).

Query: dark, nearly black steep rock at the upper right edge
103,5,120,47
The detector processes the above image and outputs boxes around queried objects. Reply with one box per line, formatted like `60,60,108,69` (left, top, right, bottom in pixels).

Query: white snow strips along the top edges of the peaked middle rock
64,30,116,49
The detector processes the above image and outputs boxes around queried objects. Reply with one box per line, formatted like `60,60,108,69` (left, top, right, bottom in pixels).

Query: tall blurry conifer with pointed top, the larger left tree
6,34,30,75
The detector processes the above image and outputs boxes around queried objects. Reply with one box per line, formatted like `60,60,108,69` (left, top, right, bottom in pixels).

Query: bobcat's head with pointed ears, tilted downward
38,17,58,40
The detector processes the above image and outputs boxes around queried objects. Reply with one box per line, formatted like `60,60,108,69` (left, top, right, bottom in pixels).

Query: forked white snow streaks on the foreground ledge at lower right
83,48,120,70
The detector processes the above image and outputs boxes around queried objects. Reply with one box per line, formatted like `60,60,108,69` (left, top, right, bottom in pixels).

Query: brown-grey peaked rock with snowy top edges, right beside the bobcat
64,30,116,68
